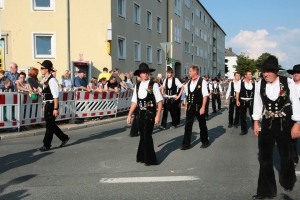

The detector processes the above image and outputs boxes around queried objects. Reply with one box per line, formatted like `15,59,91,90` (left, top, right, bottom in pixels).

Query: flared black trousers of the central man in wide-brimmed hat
136,111,157,165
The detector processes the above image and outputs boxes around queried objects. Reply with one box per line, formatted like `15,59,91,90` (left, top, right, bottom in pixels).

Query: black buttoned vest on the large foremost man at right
260,76,292,120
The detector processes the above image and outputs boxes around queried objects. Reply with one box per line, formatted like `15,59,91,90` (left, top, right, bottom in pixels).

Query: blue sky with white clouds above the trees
200,0,300,69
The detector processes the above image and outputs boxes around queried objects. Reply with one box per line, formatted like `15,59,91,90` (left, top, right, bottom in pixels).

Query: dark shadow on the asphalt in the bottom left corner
0,175,36,200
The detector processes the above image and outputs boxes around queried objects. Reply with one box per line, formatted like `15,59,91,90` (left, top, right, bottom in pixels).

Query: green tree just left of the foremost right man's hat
236,52,256,76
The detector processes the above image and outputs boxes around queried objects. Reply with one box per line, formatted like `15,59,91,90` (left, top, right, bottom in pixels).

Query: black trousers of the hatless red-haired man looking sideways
182,105,209,148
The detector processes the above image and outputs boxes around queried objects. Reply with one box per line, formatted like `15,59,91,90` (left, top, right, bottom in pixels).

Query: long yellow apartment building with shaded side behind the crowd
0,0,225,79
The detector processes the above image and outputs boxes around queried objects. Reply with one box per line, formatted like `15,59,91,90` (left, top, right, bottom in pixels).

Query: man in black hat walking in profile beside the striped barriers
38,60,70,152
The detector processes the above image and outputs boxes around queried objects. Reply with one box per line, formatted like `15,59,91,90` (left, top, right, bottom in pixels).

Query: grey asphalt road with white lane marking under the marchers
0,102,300,200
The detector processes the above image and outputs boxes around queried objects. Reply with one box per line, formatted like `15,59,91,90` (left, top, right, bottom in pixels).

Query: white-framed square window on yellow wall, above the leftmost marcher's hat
33,33,56,59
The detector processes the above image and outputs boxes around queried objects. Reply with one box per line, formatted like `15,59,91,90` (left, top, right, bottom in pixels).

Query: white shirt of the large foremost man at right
252,77,300,121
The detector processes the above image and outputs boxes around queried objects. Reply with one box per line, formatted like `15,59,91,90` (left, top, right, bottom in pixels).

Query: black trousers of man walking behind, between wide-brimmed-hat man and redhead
161,99,180,128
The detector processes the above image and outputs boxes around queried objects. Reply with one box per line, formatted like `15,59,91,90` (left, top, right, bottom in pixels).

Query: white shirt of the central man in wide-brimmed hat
131,80,163,104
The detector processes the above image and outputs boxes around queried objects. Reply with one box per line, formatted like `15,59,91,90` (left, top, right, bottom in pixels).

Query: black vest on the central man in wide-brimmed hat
136,80,156,115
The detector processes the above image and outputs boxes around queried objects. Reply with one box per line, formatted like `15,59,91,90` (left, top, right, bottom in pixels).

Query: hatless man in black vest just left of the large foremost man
235,70,255,135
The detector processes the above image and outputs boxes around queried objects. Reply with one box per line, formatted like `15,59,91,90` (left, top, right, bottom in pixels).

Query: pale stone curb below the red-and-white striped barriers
0,115,127,141
